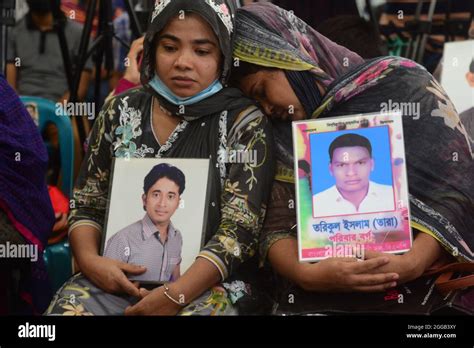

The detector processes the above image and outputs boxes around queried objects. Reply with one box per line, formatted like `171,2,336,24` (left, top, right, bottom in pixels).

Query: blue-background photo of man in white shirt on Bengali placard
309,126,395,218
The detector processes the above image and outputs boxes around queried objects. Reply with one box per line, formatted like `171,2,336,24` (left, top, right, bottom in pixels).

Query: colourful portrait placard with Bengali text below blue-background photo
293,113,412,262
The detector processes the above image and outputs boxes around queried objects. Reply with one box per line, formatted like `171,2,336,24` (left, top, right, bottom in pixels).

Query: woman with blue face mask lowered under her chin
47,0,274,315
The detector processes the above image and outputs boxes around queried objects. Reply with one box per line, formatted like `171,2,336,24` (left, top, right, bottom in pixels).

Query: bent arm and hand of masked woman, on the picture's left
65,101,146,296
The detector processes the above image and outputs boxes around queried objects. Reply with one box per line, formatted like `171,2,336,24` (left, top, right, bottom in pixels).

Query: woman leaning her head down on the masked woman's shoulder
234,4,474,291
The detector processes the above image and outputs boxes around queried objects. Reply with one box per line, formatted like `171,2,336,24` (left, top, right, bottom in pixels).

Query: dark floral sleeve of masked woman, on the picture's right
199,106,275,280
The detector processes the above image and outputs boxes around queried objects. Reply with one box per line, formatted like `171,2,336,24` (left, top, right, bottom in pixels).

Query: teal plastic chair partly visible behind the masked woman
20,96,74,291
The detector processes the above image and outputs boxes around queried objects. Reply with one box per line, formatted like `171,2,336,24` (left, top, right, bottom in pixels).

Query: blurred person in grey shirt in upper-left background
7,0,92,102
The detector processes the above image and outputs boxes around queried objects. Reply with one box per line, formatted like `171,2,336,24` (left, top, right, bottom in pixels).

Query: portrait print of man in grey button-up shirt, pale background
101,158,210,285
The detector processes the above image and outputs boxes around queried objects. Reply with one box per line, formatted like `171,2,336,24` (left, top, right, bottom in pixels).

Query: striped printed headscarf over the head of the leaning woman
234,3,364,86
